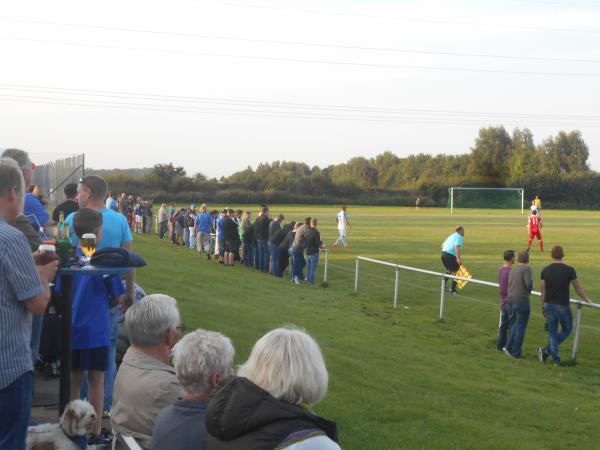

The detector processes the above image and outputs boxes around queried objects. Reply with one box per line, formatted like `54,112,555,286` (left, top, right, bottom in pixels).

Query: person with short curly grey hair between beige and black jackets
152,330,235,450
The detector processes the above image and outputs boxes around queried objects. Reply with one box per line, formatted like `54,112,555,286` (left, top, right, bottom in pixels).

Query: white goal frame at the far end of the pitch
448,187,525,214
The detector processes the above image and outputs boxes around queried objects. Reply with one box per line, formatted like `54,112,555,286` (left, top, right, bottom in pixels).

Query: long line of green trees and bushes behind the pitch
94,126,600,208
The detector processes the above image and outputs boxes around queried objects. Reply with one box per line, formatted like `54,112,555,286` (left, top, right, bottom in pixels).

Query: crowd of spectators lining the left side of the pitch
0,150,339,450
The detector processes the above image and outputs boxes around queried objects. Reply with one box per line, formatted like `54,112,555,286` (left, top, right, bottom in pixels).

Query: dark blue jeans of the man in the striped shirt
0,372,33,450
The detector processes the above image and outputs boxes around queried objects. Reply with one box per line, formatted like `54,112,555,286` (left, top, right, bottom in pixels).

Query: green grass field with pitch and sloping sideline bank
135,206,600,450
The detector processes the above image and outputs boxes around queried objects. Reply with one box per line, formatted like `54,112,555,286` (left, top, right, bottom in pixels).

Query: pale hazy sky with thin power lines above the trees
0,0,600,177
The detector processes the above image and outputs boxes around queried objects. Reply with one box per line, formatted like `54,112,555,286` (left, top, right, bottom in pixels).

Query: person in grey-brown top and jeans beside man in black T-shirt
502,252,533,358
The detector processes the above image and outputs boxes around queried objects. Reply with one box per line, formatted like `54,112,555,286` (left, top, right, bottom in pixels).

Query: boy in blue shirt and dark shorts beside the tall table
57,208,125,444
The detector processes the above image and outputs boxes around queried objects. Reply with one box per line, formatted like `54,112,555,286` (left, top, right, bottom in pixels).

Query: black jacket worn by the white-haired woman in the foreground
206,377,338,450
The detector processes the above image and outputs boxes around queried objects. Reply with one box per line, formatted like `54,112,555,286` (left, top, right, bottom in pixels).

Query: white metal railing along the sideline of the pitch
354,256,600,359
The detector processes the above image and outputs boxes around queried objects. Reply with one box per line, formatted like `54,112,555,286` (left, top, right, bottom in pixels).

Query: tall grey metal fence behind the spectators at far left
32,155,85,206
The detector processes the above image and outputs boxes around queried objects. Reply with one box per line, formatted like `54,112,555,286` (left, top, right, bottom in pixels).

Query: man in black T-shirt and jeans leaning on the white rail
538,245,591,365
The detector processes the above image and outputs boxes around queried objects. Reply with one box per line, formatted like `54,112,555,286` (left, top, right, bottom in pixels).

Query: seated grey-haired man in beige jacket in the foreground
110,294,181,450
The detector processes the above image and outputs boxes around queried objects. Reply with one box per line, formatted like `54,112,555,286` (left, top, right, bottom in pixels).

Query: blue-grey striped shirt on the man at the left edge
0,218,44,389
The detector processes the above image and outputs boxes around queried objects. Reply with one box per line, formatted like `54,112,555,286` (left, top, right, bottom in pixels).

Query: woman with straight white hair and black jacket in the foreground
206,328,340,450
